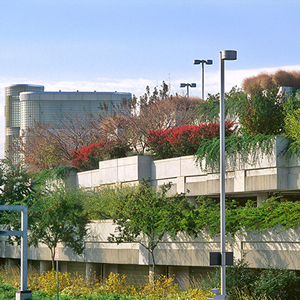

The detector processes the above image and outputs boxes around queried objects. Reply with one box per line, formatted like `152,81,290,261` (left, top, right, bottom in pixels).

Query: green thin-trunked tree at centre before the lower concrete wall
108,181,196,280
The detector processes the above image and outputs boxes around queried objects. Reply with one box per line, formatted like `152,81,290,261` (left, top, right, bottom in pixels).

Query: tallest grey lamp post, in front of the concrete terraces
220,50,237,299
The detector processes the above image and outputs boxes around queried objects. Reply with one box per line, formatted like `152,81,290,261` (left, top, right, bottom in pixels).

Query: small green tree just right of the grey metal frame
29,186,89,269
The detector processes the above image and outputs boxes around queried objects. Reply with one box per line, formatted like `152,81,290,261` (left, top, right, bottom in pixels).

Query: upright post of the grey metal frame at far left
21,206,28,291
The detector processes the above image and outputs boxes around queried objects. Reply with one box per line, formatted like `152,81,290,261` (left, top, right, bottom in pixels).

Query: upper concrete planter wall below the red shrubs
76,137,300,197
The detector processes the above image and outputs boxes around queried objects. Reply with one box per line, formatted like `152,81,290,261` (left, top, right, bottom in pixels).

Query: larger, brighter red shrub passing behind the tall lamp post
147,121,234,158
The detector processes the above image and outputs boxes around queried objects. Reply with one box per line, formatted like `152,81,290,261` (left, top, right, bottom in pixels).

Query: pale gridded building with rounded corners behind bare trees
5,84,131,158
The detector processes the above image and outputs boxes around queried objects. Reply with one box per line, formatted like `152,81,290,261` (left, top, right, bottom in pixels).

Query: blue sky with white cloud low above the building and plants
0,0,300,157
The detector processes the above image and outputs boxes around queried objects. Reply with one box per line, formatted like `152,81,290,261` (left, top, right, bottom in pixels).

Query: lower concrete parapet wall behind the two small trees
0,220,300,270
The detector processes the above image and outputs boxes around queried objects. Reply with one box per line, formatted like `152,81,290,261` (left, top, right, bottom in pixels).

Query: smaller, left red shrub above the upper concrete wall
72,139,130,171
